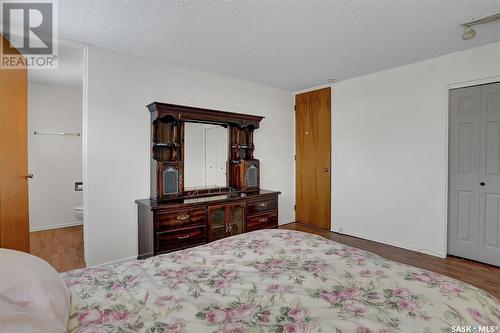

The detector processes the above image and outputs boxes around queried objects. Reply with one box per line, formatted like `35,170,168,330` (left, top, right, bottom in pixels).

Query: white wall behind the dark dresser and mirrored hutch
85,47,294,265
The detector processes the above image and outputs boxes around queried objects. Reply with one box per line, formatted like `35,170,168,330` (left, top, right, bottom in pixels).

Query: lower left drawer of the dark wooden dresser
156,227,207,253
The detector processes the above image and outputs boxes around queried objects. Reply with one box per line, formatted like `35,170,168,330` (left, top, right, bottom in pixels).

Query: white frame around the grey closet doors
446,75,500,258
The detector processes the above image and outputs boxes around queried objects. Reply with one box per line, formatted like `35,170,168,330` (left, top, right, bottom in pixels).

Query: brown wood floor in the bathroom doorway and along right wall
31,223,500,298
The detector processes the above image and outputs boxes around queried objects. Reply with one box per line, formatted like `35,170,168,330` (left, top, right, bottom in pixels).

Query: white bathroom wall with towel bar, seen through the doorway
28,83,82,231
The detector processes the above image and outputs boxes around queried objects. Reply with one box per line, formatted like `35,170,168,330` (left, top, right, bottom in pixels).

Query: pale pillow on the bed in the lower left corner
0,249,70,333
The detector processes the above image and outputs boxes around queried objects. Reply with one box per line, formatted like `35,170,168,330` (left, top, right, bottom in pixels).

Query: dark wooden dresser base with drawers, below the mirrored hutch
136,190,280,259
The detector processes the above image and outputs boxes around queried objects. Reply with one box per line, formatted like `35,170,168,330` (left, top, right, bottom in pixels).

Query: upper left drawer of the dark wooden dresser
155,208,207,232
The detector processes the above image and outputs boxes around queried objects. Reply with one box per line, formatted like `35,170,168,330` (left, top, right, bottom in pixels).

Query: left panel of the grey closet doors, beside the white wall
448,87,481,260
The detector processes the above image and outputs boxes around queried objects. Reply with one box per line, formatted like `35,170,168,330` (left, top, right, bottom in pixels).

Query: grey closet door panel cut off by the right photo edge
478,83,500,266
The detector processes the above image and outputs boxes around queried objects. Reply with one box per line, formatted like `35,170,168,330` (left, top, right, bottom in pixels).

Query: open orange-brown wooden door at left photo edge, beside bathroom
0,37,29,252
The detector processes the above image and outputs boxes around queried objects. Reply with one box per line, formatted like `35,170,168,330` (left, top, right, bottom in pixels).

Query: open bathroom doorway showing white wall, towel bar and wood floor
28,45,85,272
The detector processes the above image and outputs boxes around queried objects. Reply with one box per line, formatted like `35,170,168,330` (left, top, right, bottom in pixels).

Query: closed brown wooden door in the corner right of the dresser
295,88,331,230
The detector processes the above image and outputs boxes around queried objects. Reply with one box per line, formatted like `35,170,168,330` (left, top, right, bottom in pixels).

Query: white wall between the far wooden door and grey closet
332,43,500,256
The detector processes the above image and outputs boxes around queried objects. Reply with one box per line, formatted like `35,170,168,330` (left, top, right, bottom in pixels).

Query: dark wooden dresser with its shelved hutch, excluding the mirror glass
136,102,280,259
